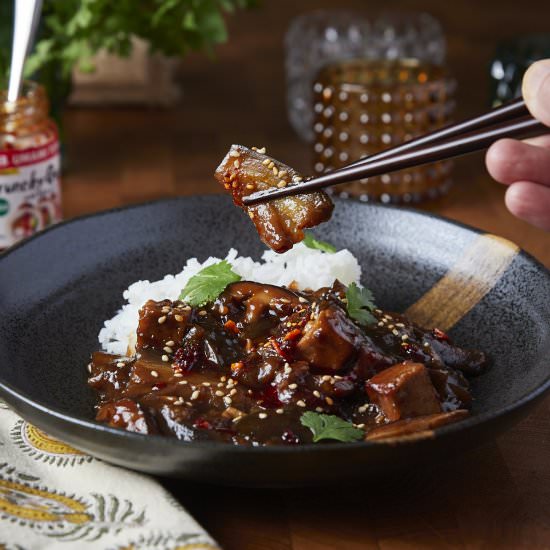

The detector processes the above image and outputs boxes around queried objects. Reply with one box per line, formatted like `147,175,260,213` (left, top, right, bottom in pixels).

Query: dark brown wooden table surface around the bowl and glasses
63,0,550,550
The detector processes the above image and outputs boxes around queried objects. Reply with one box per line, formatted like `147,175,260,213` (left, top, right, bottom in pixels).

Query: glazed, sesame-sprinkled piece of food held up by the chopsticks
215,145,334,252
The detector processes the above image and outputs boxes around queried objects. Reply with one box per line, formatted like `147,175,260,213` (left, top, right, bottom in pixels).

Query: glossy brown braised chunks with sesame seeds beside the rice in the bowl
89,281,487,445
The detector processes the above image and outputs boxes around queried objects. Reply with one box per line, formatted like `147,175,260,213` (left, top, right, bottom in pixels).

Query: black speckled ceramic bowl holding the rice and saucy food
0,196,550,486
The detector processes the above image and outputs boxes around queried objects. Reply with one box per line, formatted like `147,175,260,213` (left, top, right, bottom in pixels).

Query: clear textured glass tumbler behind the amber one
285,10,445,142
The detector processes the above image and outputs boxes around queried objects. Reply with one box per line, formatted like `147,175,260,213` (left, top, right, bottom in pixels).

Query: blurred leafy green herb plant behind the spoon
0,0,257,88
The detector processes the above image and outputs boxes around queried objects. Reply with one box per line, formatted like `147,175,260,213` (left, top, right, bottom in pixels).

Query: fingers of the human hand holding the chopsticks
485,59,550,231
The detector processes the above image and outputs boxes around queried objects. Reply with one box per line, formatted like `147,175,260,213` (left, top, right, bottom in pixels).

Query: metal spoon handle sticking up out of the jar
8,0,42,102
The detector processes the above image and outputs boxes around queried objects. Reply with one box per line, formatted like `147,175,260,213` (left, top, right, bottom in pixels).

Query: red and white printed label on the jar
0,137,62,249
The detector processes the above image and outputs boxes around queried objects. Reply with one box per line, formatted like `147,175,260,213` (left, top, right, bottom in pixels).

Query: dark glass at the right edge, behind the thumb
490,33,550,107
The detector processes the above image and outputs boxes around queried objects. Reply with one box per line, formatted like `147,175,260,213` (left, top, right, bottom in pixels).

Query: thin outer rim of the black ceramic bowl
0,193,550,454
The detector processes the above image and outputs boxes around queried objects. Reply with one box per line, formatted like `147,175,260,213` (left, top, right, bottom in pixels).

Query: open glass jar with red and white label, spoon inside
0,82,62,250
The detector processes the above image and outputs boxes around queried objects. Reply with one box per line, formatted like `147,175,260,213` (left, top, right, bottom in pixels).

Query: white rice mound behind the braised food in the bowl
98,243,361,355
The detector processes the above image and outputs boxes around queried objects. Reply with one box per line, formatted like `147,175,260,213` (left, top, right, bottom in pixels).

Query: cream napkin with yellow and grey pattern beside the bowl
0,401,219,550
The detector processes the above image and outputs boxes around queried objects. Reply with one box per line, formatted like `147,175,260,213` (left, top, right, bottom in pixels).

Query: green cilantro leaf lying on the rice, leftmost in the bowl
179,260,241,306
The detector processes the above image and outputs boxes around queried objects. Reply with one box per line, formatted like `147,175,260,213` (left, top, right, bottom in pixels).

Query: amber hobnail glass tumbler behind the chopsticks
313,59,455,203
